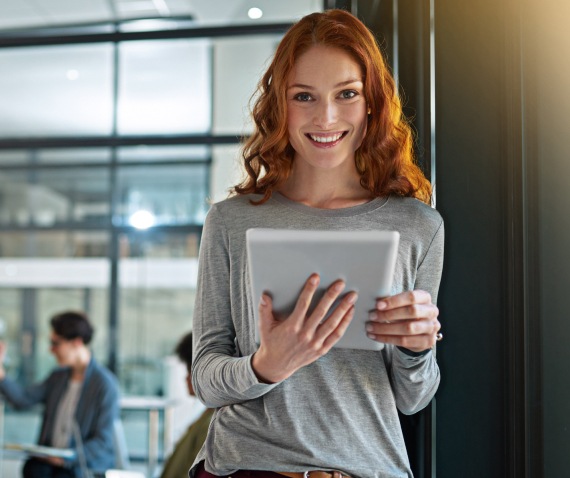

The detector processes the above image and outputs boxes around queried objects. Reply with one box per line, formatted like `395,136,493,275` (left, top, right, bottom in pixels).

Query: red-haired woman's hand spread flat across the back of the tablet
251,274,357,383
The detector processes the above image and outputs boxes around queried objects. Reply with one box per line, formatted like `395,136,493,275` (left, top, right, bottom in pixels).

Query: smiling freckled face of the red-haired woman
287,45,367,171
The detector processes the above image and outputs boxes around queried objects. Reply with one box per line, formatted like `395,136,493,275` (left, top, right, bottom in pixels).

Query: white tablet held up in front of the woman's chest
246,229,400,350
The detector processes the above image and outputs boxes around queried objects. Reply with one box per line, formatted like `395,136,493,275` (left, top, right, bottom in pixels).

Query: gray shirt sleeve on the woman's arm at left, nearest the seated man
192,205,277,408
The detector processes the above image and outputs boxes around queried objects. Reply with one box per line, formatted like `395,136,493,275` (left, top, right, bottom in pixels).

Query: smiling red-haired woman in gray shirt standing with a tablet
192,10,443,478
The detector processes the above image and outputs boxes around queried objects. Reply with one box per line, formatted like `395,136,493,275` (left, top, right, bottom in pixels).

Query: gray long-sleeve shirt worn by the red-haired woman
192,194,443,478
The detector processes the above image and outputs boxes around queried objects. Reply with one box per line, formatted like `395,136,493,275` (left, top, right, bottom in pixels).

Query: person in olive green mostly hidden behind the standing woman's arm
160,332,214,478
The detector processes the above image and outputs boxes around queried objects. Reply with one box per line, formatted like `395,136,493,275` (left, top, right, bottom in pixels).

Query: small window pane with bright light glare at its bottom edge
114,165,209,229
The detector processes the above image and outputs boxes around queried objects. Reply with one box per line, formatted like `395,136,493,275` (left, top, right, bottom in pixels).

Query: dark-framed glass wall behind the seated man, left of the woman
0,4,323,470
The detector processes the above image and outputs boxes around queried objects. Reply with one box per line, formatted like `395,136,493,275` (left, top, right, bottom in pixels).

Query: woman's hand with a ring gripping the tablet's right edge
366,290,441,352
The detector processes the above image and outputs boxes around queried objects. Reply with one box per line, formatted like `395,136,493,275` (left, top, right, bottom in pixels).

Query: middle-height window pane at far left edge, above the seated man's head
0,168,109,227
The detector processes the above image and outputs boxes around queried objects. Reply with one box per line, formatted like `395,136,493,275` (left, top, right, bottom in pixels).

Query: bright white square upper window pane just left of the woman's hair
118,40,211,135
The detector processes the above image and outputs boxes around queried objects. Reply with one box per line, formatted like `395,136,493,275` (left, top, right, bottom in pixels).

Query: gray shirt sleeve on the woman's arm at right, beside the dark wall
384,217,444,415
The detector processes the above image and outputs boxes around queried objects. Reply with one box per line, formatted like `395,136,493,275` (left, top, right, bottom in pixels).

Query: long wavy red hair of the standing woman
233,10,431,204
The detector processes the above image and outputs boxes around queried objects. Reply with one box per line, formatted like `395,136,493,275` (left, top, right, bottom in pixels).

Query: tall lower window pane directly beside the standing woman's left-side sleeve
118,233,198,395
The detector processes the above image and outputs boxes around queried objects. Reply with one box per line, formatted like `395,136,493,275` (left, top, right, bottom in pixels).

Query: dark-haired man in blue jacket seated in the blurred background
0,311,119,478
